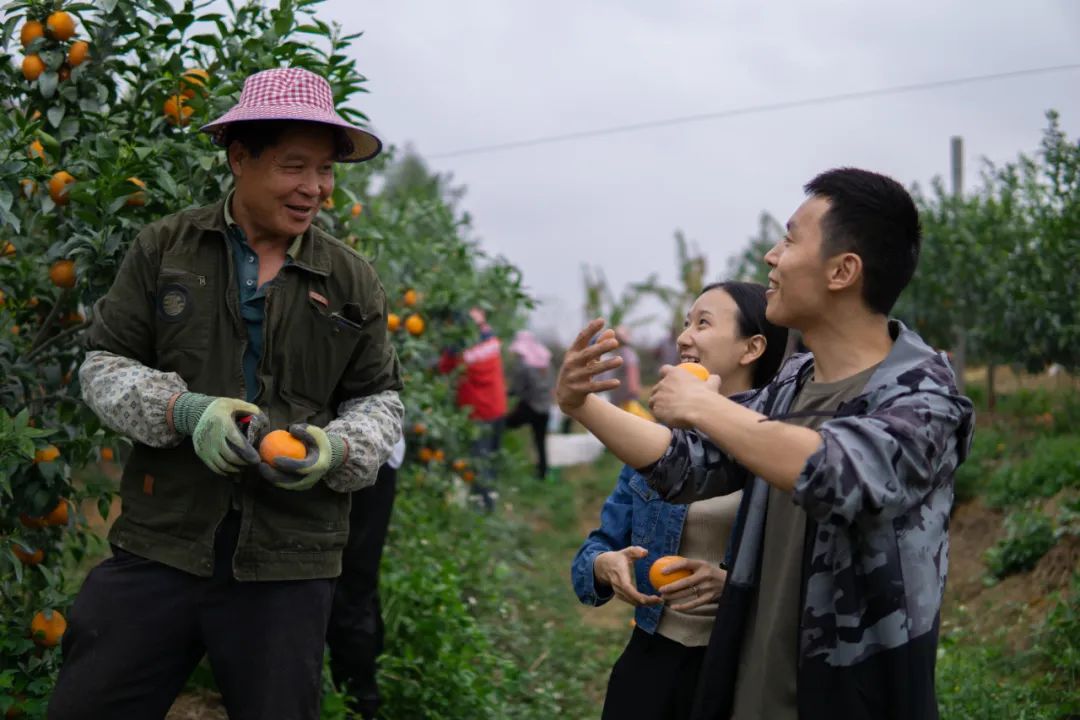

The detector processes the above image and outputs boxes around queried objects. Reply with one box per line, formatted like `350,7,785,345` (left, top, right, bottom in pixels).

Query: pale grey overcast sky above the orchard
320,0,1080,339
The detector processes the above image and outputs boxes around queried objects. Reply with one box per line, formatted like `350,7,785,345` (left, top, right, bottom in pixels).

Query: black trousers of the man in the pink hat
48,513,334,720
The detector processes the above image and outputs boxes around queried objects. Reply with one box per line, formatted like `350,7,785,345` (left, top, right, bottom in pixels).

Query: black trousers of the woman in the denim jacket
602,627,705,720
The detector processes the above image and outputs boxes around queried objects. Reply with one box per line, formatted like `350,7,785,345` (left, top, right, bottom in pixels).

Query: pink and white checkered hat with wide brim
200,68,382,163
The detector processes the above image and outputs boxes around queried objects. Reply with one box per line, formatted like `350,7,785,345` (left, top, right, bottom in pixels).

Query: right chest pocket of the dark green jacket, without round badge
282,298,365,408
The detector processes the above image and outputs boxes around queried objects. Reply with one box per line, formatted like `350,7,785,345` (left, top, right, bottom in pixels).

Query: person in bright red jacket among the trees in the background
438,308,507,512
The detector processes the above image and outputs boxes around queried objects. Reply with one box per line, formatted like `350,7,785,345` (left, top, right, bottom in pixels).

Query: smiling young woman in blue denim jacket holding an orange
571,282,787,720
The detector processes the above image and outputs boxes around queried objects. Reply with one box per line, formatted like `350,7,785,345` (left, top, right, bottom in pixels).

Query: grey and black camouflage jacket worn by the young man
646,321,974,720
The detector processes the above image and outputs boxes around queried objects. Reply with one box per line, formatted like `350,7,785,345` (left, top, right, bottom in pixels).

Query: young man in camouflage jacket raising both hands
556,168,973,720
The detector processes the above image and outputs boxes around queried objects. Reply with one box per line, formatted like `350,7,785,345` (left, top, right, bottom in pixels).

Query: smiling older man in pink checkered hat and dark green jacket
49,68,403,719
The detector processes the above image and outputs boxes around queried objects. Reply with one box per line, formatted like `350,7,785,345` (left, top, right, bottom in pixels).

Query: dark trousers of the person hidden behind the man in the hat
326,465,397,718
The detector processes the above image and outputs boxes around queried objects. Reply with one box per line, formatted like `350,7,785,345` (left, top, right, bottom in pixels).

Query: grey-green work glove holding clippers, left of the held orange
173,393,265,475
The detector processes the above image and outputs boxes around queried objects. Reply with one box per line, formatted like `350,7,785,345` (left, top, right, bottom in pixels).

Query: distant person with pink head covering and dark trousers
507,330,554,480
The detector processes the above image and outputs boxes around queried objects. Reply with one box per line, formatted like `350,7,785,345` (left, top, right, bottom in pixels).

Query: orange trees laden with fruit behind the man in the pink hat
0,0,524,717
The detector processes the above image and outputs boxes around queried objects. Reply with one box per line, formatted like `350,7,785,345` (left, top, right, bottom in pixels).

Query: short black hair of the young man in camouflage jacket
805,167,922,315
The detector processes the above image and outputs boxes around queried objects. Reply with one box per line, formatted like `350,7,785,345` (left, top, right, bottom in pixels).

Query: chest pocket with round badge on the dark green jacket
153,266,215,356
